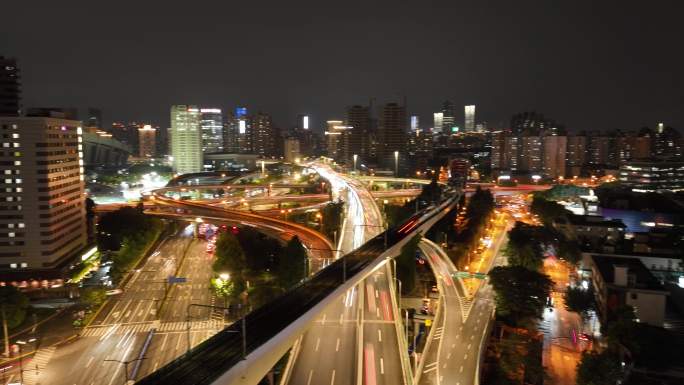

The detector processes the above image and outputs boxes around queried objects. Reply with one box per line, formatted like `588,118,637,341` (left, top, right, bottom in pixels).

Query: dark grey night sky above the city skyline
0,0,684,130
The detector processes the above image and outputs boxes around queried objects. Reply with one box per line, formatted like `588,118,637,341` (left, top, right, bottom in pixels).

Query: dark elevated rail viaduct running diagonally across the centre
139,188,460,385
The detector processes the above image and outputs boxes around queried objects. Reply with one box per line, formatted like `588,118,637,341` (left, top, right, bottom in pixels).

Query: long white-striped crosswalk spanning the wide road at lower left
81,318,225,337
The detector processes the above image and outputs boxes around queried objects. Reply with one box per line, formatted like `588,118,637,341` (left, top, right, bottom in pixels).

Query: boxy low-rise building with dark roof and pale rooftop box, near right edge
590,255,669,327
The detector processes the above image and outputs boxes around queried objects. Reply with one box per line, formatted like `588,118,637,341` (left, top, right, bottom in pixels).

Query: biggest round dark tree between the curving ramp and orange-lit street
489,266,553,326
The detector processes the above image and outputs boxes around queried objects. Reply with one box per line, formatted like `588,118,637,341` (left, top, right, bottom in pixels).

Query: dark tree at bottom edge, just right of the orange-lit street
577,350,621,385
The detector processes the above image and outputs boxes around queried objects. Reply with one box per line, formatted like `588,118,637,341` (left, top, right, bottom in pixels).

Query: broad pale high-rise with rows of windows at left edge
0,117,87,279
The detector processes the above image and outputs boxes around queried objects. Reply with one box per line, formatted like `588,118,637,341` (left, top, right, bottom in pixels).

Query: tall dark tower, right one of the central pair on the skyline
378,103,408,169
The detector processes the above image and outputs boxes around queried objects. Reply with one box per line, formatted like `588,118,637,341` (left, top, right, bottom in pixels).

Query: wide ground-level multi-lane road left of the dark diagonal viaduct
38,227,223,385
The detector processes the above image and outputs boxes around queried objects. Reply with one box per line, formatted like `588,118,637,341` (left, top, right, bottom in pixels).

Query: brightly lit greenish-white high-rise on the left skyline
170,105,202,174
